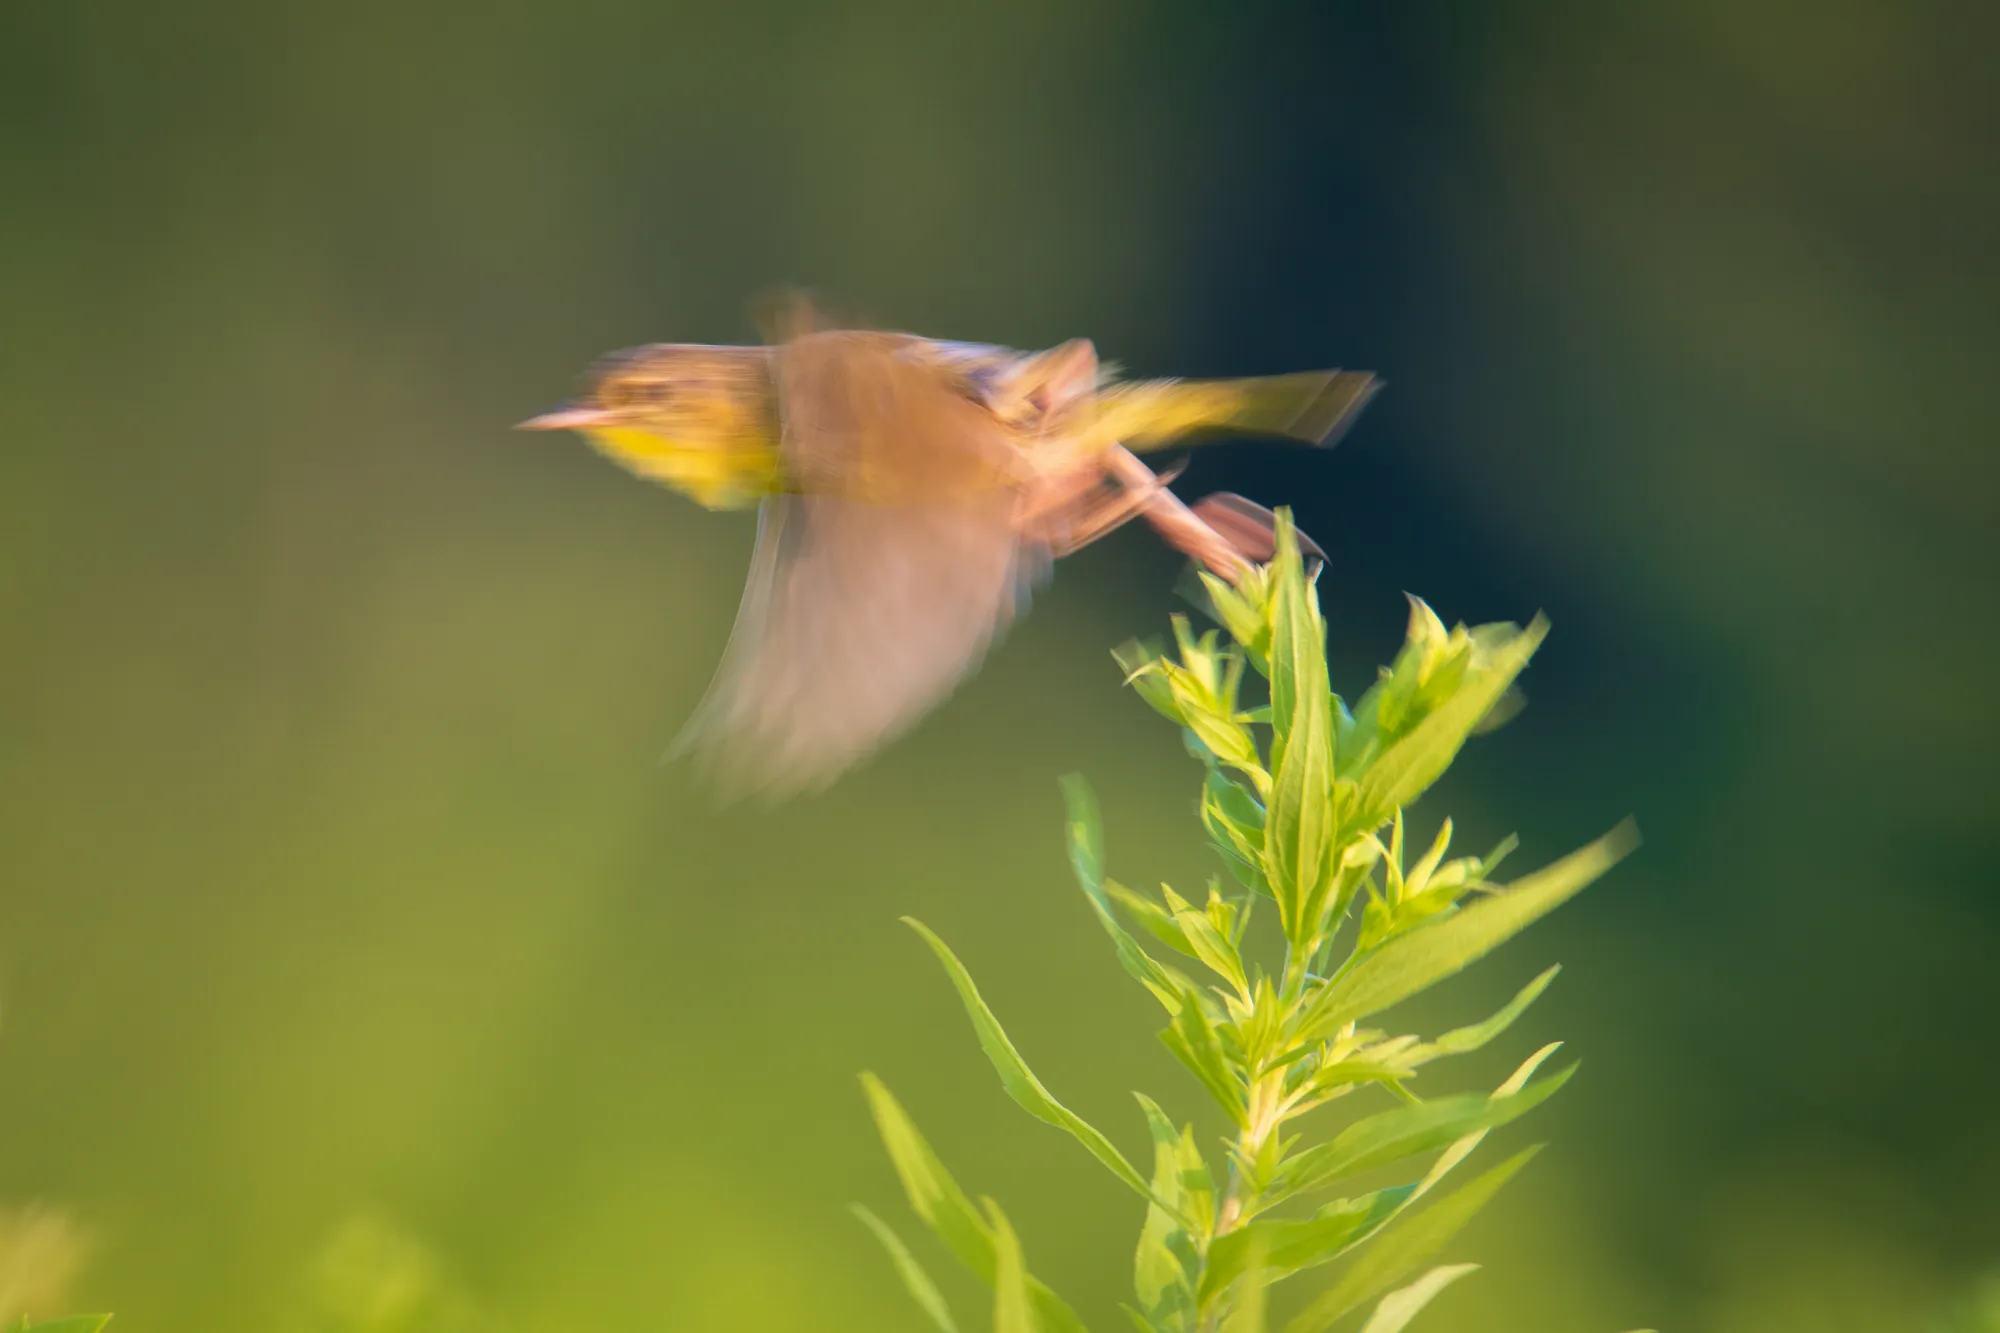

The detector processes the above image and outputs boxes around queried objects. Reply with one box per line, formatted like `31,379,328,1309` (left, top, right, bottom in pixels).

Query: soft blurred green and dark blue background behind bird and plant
0,0,2000,1333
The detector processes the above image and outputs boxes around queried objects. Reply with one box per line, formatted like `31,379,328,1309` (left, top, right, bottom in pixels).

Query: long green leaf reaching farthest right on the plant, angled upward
1300,819,1638,1037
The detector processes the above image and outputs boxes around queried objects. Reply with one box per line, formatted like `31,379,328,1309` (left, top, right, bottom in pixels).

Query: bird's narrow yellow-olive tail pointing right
1098,370,1382,452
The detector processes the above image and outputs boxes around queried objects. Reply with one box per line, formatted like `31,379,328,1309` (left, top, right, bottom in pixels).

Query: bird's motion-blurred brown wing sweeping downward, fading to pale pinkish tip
682,314,1046,797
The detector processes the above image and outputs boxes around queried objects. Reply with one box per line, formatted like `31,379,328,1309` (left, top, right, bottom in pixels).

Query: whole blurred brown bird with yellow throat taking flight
520,296,1380,797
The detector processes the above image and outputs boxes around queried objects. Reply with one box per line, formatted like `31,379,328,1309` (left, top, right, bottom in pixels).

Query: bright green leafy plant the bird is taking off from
856,514,1638,1333
